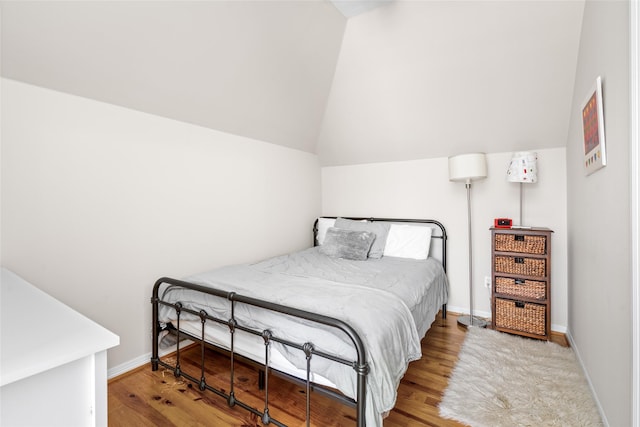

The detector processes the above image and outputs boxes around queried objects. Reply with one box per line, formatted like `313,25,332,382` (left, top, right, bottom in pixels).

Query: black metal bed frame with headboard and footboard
151,217,447,427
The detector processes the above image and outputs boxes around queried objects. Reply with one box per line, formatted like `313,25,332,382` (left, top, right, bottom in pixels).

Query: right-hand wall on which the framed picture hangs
567,1,637,426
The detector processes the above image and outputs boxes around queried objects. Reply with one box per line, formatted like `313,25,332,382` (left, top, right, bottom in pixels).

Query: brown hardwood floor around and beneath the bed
108,313,566,427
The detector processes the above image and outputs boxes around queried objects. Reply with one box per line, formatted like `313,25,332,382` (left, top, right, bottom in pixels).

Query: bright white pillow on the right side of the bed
384,224,433,259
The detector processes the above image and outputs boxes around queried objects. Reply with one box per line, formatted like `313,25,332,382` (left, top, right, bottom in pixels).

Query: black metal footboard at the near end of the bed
151,277,369,427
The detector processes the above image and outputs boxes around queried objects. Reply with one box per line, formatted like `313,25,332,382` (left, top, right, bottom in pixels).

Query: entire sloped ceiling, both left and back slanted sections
0,0,583,165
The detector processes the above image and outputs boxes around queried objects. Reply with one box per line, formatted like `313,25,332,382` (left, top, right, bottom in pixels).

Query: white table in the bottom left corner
0,268,120,427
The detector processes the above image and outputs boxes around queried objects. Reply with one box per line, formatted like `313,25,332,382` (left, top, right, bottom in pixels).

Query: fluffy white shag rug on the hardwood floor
440,327,603,427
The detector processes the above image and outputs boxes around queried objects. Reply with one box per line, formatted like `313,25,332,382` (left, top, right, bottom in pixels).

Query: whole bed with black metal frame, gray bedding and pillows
151,217,448,427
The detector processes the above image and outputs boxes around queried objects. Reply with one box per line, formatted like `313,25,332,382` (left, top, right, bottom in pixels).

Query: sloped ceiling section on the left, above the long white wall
1,0,346,152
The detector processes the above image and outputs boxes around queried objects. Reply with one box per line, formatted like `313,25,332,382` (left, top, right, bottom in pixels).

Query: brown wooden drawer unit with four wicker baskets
491,228,552,339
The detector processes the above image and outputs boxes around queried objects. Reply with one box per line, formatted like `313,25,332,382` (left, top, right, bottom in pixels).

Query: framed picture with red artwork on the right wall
582,76,607,175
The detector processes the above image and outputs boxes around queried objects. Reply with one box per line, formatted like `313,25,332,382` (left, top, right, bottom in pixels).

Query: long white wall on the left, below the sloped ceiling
1,79,320,367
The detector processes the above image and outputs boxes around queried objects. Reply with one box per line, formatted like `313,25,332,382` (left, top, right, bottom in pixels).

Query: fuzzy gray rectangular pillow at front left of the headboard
320,227,376,261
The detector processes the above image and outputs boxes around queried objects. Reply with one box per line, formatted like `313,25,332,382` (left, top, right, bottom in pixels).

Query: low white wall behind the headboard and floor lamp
322,148,567,332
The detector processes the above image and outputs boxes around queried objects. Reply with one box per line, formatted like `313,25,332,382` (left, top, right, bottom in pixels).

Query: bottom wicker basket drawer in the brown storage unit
496,298,547,336
